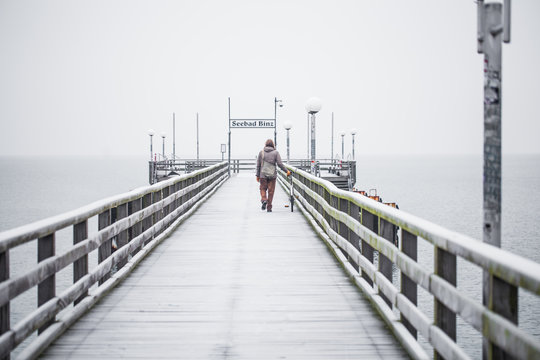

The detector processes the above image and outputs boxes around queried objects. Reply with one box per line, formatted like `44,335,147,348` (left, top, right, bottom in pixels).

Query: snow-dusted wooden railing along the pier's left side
0,162,228,358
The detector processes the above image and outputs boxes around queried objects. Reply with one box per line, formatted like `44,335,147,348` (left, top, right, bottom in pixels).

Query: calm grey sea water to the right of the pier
356,155,540,359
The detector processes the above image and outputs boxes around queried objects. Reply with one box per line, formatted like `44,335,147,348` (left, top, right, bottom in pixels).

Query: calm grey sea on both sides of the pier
0,155,540,358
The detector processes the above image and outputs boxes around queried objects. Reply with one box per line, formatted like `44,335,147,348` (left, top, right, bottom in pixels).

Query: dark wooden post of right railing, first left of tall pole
434,247,457,359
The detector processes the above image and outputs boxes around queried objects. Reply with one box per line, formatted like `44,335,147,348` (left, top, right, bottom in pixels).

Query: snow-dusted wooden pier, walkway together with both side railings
0,162,540,360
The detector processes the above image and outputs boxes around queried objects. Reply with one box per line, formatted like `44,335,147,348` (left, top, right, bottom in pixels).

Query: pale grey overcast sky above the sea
0,0,540,158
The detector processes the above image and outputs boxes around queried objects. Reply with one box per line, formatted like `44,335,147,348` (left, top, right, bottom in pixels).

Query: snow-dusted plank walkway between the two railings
42,174,408,359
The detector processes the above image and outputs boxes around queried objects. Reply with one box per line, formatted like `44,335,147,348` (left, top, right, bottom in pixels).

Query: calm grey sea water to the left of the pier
0,157,148,358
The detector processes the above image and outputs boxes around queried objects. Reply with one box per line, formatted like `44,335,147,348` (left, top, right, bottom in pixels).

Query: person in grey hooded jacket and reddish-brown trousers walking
255,139,291,212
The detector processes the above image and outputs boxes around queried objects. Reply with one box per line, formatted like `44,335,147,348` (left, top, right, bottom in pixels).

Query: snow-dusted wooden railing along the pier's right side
280,165,540,359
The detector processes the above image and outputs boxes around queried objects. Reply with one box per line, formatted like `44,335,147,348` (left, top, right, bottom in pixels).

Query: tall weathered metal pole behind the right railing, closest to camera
477,0,518,359
